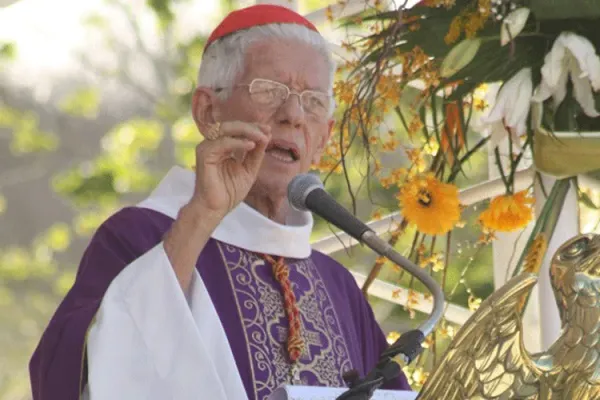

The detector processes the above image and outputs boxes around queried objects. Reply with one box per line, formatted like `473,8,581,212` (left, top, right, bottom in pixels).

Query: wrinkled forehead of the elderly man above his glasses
242,39,330,91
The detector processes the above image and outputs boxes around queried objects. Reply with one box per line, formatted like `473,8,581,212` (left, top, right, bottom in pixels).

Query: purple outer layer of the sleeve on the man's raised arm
29,209,153,400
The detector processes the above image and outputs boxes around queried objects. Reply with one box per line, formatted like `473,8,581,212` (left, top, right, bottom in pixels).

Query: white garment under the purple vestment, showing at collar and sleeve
85,167,313,400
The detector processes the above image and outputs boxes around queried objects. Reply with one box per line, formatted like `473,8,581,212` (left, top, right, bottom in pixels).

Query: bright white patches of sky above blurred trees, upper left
0,0,219,79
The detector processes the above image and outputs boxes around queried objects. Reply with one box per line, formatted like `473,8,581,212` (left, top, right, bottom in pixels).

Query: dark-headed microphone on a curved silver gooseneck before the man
288,174,444,354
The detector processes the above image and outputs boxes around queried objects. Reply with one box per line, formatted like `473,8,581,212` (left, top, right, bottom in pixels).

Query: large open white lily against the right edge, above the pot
533,32,600,117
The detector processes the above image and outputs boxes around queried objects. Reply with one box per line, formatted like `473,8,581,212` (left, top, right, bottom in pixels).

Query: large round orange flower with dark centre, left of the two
398,175,460,235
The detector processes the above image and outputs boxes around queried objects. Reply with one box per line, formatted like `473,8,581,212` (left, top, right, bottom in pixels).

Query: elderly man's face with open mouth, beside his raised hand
219,39,333,194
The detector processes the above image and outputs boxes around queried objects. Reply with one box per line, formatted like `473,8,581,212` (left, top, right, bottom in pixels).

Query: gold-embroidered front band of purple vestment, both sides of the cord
218,243,352,400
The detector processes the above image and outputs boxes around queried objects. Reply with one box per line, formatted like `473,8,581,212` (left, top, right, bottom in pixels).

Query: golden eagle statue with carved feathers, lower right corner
417,235,600,400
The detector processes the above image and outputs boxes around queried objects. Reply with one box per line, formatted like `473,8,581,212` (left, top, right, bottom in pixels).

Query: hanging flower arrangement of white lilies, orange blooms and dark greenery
318,0,600,388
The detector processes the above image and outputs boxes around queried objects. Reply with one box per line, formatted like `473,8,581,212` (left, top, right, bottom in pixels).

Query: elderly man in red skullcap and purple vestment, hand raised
30,5,408,400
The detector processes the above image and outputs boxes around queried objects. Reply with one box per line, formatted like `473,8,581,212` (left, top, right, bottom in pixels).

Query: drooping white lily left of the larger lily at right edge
481,68,533,147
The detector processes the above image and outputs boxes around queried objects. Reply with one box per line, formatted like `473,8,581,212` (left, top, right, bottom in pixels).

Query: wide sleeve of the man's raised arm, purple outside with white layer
30,209,245,400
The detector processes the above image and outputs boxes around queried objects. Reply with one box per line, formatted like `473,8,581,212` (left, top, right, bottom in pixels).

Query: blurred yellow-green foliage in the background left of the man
0,0,225,400
